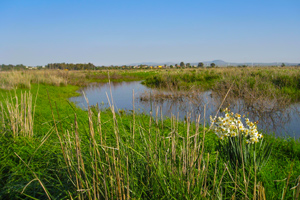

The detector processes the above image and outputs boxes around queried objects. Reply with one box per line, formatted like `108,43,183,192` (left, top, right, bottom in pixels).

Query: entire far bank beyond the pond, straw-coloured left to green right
0,67,300,102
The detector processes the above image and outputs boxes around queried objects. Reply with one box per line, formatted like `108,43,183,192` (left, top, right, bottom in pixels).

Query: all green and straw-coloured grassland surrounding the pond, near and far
0,67,300,199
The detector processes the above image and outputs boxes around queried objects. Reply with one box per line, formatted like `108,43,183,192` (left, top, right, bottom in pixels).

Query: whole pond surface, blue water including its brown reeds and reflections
70,81,300,138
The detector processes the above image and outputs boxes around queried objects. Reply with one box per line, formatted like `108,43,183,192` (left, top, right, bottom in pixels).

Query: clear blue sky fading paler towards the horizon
0,0,300,66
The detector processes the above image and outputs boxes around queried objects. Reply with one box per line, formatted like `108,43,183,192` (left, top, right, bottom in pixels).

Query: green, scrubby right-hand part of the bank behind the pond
144,67,300,101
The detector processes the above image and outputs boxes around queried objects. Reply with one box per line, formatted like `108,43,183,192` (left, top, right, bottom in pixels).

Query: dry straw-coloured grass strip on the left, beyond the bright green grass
0,69,157,89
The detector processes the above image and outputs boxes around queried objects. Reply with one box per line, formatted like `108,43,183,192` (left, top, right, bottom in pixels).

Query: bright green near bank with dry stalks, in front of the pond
0,72,300,199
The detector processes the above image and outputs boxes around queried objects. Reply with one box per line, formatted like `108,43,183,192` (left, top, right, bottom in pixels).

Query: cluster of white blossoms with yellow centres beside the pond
210,108,263,144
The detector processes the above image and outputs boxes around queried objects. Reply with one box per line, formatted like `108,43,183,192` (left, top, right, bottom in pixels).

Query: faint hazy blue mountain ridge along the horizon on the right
129,60,300,67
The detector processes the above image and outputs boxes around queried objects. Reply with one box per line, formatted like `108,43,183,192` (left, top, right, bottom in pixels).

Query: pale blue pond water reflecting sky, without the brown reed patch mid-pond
70,81,300,138
